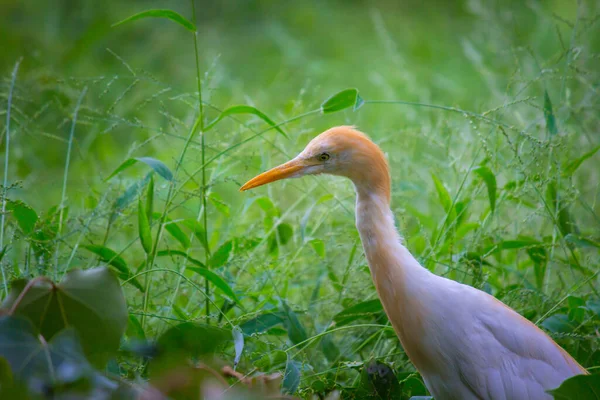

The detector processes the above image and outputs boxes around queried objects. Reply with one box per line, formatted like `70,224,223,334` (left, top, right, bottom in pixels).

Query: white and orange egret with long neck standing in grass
240,126,587,400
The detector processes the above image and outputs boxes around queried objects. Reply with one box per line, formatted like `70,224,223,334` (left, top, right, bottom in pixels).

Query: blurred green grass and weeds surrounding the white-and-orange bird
0,0,600,398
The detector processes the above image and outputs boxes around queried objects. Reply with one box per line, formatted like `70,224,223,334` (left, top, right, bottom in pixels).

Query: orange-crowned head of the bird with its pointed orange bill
240,126,390,200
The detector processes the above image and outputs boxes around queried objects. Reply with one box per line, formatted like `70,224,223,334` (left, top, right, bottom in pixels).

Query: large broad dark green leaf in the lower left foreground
2,267,128,367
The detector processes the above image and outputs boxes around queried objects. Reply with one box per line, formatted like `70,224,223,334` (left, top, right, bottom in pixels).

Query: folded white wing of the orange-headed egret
456,291,586,400
